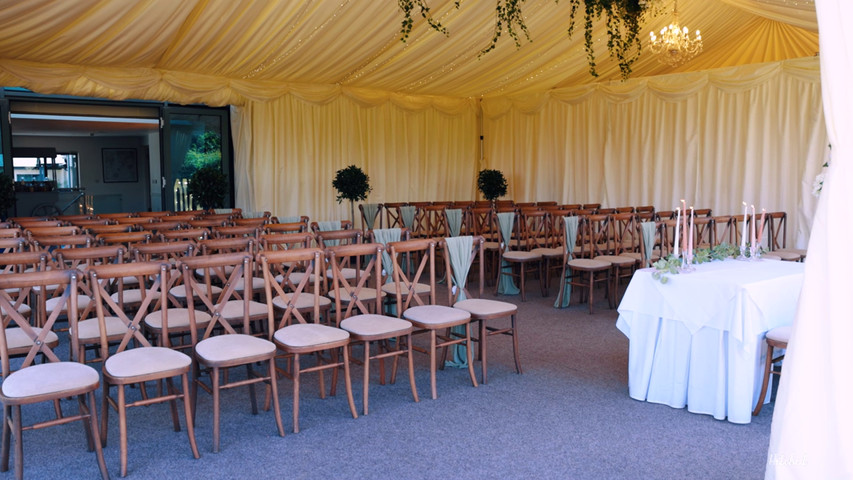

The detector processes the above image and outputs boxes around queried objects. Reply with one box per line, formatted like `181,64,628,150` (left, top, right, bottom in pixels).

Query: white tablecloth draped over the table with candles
616,260,804,423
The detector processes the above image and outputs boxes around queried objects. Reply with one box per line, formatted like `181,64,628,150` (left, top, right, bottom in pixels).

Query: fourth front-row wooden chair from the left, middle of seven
258,248,358,433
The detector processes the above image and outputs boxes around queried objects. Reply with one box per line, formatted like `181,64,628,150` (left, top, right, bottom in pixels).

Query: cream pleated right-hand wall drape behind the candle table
482,58,828,247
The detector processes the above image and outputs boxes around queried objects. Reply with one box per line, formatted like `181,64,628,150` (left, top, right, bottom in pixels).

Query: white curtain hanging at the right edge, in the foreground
766,0,853,479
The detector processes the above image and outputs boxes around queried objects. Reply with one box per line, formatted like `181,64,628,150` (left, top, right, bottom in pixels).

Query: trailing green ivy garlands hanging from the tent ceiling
397,0,657,79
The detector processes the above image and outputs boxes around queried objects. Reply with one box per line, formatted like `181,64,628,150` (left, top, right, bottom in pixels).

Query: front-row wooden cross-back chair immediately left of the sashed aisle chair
389,237,477,399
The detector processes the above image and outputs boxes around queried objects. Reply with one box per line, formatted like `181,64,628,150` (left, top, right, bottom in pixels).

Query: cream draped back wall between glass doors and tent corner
232,95,478,220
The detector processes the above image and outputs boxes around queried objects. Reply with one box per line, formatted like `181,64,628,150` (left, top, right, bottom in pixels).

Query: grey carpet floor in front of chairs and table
0,288,773,479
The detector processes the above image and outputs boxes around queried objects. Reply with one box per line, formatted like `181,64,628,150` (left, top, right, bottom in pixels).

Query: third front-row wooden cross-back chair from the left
180,252,284,452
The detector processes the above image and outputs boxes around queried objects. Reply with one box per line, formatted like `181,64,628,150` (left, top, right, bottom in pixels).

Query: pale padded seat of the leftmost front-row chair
0,362,101,398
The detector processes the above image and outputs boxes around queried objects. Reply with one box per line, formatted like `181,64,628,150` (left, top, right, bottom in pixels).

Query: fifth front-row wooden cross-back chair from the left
326,243,419,415
